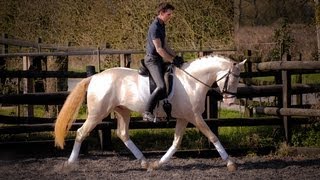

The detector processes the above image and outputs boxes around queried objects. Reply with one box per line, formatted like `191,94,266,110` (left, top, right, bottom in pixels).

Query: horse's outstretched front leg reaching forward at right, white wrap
193,115,237,171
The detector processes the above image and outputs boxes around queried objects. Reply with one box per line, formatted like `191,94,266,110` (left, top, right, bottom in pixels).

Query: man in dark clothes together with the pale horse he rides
54,3,246,171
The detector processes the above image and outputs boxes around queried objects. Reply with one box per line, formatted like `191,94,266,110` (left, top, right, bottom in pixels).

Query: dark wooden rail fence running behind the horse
0,35,320,148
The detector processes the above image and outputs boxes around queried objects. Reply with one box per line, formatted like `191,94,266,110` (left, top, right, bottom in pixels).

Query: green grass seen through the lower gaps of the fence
0,107,320,151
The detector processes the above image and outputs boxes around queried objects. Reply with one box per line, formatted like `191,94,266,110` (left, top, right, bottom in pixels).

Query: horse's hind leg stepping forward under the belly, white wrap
115,108,148,169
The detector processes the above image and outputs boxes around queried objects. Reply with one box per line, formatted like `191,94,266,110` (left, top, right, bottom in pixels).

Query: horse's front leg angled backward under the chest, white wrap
148,119,188,171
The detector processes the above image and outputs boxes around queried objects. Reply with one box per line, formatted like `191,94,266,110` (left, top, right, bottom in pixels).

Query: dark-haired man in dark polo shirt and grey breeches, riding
143,3,183,121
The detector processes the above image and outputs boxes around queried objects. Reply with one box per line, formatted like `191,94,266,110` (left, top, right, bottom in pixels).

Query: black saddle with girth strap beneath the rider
138,59,173,121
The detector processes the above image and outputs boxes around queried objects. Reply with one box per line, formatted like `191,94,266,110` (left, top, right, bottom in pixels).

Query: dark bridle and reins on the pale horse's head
180,68,240,98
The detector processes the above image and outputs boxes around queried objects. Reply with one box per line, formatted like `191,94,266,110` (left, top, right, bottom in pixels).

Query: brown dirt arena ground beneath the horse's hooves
0,151,320,180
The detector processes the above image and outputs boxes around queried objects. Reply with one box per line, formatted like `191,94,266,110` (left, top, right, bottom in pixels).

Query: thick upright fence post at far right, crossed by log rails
281,54,291,144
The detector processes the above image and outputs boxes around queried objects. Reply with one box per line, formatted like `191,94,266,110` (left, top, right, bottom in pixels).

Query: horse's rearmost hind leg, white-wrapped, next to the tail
68,114,103,163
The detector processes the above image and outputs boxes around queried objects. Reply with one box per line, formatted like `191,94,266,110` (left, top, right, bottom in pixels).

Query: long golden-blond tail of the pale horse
54,77,91,149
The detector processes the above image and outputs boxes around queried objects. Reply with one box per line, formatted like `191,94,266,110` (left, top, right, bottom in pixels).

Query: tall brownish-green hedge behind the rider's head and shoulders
0,0,233,49
